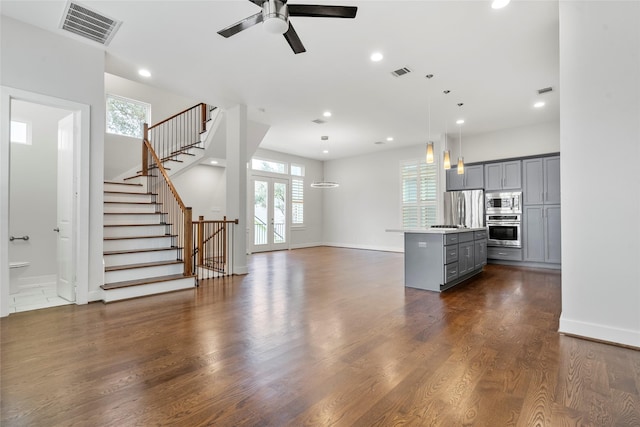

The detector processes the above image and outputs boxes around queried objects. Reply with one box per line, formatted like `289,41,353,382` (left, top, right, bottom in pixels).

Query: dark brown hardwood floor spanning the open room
0,247,640,427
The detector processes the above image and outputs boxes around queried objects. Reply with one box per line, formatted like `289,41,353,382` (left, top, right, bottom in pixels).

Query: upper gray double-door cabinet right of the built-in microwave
522,156,560,205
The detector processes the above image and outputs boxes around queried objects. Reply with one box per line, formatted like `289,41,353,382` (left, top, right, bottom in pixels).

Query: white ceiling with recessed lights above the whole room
1,0,559,159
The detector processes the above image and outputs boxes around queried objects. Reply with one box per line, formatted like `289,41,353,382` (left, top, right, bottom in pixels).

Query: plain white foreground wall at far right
560,1,640,347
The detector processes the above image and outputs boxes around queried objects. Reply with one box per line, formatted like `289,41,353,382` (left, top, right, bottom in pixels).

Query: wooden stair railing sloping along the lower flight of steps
143,138,193,276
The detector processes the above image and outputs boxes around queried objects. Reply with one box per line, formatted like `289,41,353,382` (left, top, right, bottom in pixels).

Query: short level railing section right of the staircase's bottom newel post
192,216,238,280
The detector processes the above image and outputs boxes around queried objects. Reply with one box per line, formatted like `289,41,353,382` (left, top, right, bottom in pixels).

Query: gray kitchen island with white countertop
404,228,487,292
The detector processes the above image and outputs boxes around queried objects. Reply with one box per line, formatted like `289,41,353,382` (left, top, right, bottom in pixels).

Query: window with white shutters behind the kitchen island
400,160,438,228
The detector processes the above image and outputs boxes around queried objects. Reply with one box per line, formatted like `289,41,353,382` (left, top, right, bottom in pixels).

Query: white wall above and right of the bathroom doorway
0,16,105,304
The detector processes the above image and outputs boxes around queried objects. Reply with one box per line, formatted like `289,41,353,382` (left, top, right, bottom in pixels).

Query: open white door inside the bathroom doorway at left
54,113,76,301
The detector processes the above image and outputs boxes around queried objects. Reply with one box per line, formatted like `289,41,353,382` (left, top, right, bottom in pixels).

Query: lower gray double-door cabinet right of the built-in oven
523,205,562,264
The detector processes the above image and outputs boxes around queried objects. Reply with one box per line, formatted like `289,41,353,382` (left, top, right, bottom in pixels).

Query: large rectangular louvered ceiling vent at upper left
60,1,122,46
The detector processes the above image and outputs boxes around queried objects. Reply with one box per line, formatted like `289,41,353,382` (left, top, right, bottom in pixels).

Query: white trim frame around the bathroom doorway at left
0,86,91,317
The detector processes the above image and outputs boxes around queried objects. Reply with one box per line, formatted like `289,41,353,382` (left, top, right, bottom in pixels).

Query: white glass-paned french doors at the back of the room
249,177,289,252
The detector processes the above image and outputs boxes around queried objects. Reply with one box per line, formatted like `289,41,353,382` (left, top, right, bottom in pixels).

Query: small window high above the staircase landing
107,95,151,138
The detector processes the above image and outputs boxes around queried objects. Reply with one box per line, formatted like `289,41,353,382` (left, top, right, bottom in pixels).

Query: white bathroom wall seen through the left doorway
9,100,70,279
